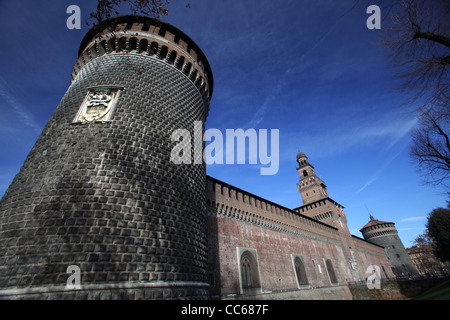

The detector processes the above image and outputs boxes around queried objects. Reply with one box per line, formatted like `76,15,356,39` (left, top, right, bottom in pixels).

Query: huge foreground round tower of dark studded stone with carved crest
0,16,213,299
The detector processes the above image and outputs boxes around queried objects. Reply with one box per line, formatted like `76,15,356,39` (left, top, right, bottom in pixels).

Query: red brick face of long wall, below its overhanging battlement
210,212,356,299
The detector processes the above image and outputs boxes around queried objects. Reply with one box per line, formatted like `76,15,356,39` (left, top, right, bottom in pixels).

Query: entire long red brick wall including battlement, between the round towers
207,177,392,299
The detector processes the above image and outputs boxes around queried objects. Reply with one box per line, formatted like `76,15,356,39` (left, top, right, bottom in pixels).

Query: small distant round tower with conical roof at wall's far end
359,215,419,278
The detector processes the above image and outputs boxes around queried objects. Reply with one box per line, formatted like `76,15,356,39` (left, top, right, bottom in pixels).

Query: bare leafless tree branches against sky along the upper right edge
381,0,450,192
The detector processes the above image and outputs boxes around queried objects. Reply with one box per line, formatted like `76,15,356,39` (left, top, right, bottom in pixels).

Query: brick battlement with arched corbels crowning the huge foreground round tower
72,16,213,112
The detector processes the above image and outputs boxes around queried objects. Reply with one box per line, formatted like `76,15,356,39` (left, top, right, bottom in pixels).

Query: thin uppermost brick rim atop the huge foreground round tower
78,15,214,97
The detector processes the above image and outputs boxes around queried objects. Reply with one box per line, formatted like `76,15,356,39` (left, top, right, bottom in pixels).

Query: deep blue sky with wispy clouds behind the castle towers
0,0,447,246
